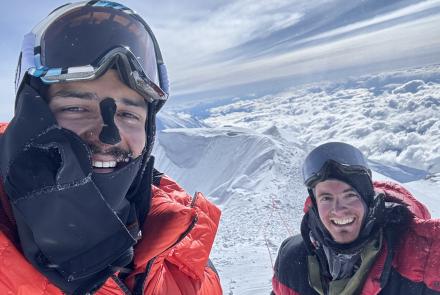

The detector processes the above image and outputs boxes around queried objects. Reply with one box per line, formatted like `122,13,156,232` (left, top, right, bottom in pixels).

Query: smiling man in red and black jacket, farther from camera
272,142,440,295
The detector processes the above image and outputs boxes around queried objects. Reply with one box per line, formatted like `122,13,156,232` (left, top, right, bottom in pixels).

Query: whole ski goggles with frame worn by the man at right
302,142,371,188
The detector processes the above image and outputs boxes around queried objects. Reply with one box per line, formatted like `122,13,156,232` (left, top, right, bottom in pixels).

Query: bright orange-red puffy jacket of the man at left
0,124,222,295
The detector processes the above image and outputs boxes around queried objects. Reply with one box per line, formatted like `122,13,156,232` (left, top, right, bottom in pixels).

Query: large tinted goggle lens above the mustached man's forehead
40,6,158,84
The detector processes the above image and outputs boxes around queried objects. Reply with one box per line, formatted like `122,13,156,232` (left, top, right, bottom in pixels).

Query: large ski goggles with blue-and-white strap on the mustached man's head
16,1,169,103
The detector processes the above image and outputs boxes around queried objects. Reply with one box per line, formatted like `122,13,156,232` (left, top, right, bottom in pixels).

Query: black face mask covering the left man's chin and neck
0,77,155,294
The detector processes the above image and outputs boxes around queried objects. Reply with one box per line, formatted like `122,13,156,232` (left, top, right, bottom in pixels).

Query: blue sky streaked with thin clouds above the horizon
0,0,440,120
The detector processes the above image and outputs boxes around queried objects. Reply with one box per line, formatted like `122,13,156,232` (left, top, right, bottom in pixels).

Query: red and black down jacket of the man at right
272,182,440,295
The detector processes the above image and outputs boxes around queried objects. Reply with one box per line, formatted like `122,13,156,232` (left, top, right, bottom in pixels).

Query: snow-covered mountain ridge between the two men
153,126,306,294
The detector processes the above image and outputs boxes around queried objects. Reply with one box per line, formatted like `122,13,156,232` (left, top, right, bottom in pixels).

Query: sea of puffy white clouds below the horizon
204,65,440,175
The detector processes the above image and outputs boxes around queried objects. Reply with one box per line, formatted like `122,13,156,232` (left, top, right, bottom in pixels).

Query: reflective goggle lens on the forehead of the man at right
303,143,368,185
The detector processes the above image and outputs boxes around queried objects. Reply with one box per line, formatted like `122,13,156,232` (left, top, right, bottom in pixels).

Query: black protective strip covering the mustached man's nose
99,97,121,145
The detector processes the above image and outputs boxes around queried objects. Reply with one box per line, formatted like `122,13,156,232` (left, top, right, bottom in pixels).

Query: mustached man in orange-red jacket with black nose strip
0,1,222,295
